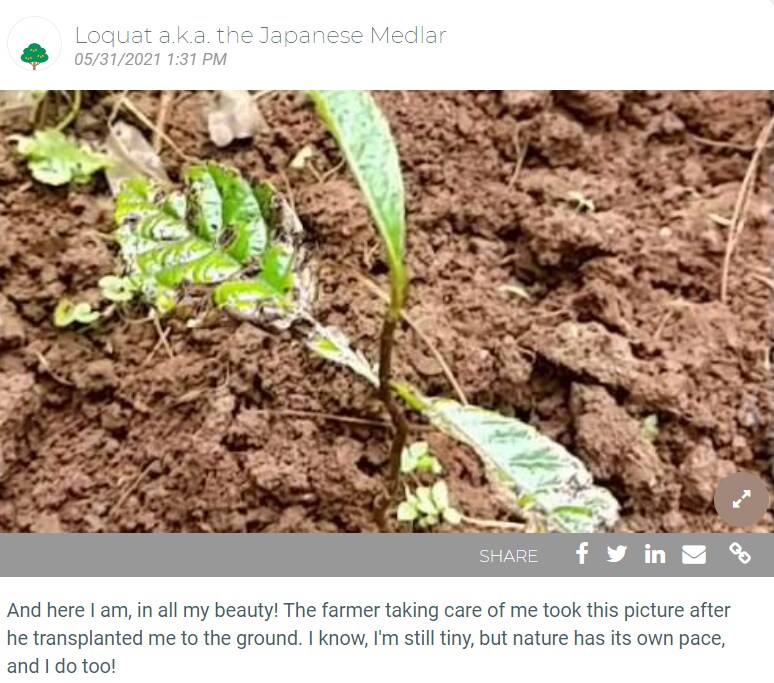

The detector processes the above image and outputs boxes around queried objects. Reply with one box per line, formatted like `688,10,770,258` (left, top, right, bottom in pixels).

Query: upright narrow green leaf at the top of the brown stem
310,90,406,313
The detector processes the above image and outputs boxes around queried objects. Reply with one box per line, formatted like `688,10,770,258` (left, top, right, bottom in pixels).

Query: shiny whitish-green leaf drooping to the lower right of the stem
396,384,619,533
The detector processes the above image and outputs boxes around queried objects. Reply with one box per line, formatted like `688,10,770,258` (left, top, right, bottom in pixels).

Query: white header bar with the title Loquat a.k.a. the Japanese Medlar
0,0,774,89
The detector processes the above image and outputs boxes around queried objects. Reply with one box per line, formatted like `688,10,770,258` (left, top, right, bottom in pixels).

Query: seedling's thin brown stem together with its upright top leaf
311,90,408,490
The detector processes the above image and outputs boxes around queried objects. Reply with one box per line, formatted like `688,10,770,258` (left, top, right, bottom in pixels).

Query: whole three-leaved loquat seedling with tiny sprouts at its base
45,91,618,533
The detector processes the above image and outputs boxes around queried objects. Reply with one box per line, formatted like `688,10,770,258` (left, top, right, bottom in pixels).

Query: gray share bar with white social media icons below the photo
0,533,774,577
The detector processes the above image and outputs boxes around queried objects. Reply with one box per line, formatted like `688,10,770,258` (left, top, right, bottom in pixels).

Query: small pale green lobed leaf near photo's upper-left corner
10,128,108,186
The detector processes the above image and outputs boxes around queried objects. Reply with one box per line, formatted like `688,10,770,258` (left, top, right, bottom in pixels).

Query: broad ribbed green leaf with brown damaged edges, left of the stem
110,162,314,330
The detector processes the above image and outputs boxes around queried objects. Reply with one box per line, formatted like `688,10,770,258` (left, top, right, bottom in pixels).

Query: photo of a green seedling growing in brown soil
0,89,774,533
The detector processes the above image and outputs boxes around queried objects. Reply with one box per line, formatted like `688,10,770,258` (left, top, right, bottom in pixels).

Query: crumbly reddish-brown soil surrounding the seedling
0,91,774,532
